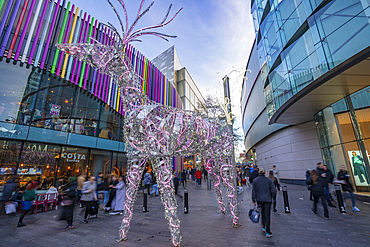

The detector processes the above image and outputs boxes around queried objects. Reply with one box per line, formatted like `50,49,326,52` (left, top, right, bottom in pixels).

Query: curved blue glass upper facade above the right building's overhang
252,0,370,119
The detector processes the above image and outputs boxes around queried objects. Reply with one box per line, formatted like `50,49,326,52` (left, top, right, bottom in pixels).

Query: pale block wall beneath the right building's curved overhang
255,121,322,180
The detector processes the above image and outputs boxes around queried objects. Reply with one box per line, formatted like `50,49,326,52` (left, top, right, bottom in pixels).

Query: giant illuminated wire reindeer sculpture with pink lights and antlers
57,0,238,246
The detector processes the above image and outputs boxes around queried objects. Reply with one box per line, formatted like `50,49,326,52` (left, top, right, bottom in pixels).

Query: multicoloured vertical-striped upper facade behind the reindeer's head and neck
0,0,182,173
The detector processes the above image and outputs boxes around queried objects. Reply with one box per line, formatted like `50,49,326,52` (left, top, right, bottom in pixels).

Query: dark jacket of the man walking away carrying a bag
252,174,275,202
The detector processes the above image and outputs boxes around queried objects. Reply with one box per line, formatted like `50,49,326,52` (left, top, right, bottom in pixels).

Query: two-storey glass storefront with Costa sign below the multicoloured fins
0,60,127,189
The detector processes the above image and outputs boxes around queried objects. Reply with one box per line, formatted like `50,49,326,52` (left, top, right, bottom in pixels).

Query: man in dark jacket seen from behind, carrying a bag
252,168,275,238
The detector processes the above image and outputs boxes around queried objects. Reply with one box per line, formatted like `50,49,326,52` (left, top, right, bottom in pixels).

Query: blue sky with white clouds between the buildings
75,0,254,139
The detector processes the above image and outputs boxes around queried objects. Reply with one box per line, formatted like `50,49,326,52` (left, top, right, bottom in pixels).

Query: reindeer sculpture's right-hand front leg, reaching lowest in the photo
153,158,181,246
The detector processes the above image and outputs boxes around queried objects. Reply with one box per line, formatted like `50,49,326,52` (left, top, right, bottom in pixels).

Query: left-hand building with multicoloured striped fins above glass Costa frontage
0,0,182,185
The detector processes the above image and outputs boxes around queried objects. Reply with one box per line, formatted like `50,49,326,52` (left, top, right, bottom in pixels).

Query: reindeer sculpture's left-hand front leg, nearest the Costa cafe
117,158,146,242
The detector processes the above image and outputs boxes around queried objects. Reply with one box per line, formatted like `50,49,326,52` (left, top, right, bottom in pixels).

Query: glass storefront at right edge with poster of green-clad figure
315,87,370,192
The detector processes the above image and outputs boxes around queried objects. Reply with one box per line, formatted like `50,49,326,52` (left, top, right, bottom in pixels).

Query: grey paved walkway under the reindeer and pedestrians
0,179,370,247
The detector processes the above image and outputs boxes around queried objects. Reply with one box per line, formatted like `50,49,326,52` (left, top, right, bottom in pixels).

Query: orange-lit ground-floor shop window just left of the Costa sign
17,142,60,189
